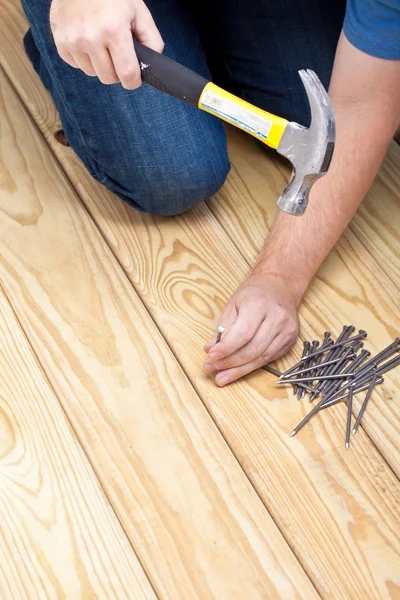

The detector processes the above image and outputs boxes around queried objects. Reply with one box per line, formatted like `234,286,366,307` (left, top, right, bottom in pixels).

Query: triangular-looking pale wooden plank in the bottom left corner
0,289,156,600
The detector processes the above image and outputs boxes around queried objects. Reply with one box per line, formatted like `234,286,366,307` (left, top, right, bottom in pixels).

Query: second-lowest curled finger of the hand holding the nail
209,319,279,372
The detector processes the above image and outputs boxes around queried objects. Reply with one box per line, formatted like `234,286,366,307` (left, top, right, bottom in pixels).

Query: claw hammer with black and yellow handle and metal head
134,40,336,215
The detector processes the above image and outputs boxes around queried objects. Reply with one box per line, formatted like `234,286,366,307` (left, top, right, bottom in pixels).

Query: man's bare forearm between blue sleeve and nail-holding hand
256,36,400,301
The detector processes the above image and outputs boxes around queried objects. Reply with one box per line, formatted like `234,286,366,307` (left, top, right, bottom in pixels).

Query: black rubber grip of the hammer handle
133,39,209,106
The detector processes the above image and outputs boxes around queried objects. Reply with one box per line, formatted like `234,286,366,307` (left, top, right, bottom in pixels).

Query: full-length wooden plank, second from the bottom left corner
0,55,318,600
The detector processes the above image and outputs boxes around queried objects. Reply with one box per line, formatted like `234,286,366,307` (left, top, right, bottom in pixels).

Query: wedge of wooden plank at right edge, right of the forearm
350,142,400,290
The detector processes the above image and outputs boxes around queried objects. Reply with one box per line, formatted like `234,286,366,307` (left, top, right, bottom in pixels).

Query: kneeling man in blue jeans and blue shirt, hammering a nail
23,0,400,385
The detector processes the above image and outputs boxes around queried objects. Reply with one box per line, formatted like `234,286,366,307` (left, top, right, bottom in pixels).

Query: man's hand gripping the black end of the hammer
50,0,164,90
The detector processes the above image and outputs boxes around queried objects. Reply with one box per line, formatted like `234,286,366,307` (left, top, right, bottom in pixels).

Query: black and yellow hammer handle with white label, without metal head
133,40,288,149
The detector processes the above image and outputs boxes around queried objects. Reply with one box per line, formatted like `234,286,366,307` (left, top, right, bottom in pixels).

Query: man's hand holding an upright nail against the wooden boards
204,270,299,386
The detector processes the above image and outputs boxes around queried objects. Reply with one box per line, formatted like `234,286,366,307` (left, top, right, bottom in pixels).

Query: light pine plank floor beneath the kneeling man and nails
0,0,400,600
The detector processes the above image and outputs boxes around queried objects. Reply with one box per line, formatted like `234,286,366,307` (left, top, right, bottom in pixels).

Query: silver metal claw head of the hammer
277,70,336,215
